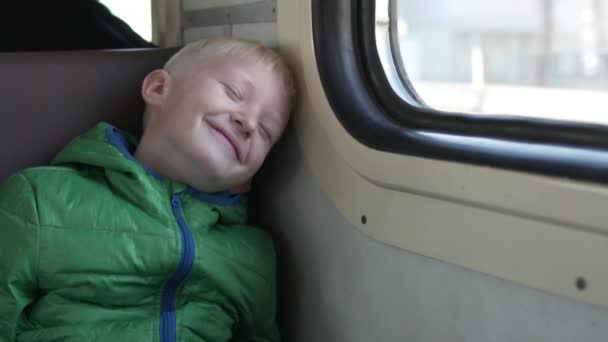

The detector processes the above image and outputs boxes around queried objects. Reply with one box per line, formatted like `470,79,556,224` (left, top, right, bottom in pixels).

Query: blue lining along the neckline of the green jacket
105,126,243,205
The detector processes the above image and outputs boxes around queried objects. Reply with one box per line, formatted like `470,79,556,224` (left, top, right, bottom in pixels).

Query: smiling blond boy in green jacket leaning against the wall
0,39,293,342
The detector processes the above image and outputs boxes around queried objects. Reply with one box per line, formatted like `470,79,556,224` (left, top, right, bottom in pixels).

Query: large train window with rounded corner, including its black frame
311,0,608,183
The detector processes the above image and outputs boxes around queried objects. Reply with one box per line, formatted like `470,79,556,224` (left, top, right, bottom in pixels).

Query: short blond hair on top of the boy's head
164,38,296,108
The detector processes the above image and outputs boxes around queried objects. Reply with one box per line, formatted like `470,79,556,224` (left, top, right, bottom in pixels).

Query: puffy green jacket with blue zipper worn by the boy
0,123,279,342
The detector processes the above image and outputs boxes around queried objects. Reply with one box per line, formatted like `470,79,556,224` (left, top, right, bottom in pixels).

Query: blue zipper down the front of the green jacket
160,194,194,342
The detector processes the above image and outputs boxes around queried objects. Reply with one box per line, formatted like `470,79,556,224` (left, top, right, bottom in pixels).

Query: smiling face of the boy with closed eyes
146,55,288,192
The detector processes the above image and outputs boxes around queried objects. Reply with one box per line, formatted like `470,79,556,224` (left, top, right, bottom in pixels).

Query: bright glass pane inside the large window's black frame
376,0,608,124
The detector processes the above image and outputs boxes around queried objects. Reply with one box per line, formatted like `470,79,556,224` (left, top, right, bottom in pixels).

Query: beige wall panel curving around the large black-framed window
278,0,608,306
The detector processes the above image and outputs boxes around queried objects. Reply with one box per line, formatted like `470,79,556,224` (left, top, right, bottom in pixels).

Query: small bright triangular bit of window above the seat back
99,0,152,41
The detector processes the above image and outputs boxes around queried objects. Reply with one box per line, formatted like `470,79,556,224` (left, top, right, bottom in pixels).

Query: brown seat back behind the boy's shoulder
0,49,175,179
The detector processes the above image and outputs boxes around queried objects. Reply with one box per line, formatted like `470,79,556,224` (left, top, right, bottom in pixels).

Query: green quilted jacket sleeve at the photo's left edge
0,174,38,341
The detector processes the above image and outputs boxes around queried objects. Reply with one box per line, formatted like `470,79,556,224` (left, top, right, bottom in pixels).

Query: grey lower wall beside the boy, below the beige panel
251,125,608,342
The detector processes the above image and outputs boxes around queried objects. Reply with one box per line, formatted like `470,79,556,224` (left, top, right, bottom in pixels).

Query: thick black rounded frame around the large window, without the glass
312,0,608,183
